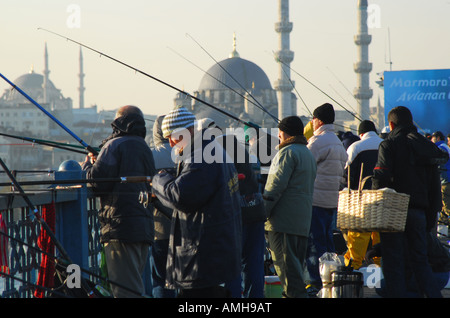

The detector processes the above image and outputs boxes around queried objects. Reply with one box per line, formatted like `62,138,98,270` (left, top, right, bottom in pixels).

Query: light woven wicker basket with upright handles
337,168,409,232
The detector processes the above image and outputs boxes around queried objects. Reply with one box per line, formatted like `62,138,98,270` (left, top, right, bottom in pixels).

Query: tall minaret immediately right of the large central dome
274,0,297,120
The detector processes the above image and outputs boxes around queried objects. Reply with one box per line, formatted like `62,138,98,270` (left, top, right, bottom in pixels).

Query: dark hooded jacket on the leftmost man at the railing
83,114,155,243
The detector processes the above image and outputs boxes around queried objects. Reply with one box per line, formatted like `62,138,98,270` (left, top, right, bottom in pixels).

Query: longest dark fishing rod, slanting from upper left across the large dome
38,28,260,129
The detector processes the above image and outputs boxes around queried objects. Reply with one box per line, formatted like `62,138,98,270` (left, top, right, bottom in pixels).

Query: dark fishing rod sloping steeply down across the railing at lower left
0,158,94,298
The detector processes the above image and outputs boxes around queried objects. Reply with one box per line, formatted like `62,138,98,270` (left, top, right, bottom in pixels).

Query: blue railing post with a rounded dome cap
55,160,89,269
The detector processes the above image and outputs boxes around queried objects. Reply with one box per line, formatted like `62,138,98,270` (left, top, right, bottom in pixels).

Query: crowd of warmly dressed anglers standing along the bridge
82,103,450,298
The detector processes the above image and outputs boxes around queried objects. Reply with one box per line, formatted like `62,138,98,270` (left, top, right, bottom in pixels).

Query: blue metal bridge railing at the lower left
0,171,101,298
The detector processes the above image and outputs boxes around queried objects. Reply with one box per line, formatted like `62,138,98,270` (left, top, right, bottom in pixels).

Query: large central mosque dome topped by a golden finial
186,37,278,127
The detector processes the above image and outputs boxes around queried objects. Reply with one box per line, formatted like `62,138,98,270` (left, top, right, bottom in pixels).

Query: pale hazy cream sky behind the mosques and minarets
0,0,450,115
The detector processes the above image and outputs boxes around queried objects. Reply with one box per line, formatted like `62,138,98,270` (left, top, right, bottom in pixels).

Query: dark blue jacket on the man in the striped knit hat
152,130,242,289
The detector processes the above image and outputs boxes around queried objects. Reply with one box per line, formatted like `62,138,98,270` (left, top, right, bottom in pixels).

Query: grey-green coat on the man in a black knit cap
264,136,316,237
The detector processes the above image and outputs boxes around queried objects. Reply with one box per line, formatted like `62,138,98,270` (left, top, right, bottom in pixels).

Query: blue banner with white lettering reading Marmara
384,69,450,135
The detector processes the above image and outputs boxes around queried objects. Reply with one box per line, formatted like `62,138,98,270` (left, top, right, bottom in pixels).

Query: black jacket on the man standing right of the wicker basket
372,125,448,229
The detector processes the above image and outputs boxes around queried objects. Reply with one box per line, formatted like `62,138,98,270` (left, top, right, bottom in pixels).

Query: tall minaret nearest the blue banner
353,0,373,120
